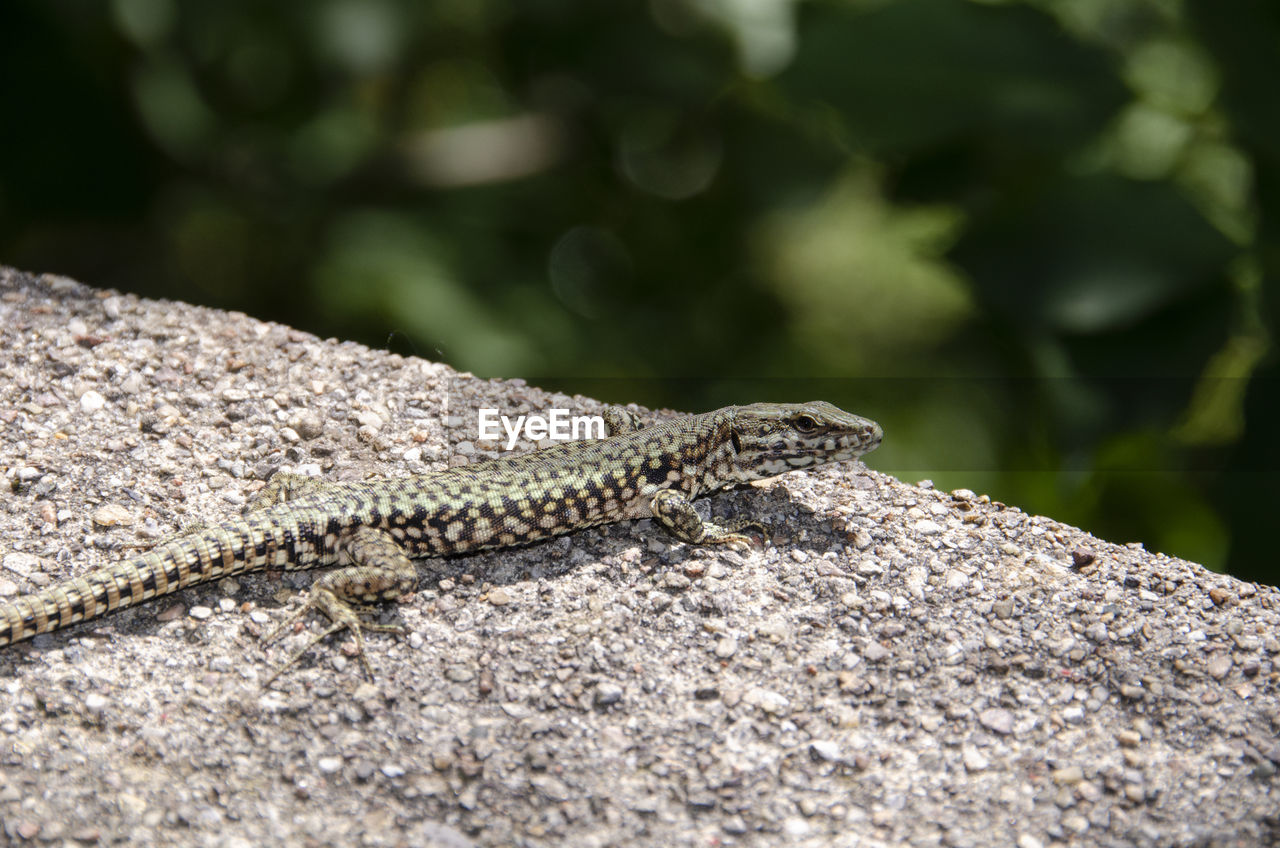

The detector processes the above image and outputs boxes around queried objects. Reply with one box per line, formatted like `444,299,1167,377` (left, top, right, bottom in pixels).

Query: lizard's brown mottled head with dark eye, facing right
728,401,883,480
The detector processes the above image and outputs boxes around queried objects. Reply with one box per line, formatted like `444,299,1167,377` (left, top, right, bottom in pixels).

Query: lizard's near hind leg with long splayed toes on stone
262,528,417,687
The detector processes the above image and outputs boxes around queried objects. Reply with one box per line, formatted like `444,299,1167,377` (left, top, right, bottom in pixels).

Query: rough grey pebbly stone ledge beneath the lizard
0,269,1280,848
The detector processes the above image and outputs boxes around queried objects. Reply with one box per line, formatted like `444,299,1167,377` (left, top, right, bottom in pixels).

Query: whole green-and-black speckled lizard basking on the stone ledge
0,401,882,685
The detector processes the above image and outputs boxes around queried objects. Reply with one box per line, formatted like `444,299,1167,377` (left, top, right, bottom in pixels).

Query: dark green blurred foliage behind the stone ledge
0,0,1280,583
